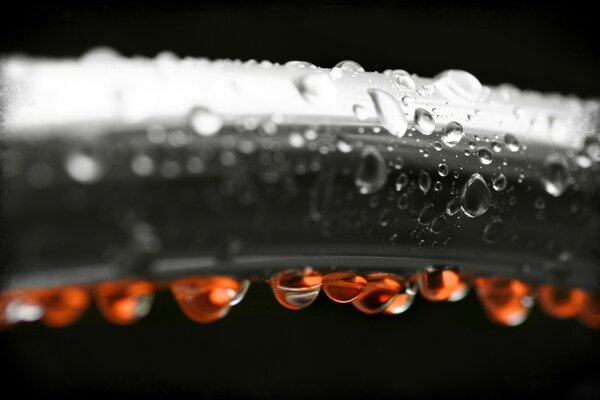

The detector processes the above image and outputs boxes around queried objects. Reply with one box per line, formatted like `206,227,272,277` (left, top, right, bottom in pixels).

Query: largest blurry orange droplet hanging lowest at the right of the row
476,278,533,326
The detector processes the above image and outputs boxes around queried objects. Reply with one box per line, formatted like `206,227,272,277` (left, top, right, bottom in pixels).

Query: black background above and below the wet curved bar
0,0,600,399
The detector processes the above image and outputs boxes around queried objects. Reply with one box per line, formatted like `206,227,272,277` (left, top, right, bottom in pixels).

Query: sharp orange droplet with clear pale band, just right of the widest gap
270,268,323,310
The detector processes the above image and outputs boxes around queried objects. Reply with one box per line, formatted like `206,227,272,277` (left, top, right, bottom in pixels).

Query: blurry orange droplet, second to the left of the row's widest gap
95,280,154,325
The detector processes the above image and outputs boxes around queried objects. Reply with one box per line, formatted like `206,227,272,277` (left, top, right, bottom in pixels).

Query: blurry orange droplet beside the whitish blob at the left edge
32,286,90,328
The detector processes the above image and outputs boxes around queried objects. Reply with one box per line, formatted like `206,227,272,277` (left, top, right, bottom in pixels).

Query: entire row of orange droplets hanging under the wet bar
0,267,600,329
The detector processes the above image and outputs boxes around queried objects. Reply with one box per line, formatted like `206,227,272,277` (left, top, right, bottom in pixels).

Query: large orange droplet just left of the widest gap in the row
169,276,241,323
